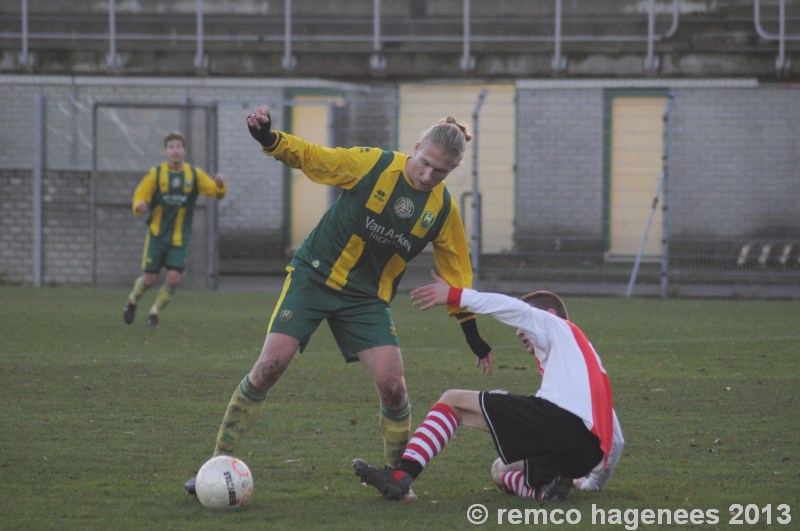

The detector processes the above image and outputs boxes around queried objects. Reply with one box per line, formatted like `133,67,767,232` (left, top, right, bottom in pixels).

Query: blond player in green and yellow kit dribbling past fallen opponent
186,107,494,494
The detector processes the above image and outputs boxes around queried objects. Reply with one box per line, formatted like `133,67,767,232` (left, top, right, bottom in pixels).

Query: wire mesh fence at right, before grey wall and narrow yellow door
488,83,800,298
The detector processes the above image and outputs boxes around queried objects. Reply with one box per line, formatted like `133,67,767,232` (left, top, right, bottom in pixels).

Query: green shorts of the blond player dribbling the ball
267,266,399,363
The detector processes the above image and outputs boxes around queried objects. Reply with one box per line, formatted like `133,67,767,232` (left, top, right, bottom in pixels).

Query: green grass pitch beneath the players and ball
0,286,800,530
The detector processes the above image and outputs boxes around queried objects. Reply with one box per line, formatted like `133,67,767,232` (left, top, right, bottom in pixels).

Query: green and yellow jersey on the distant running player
133,162,228,247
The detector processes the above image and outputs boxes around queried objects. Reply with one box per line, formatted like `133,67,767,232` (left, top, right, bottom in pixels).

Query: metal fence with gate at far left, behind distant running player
0,94,218,288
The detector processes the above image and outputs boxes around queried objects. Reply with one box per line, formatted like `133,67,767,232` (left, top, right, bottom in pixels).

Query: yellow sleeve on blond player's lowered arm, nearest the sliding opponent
433,197,475,322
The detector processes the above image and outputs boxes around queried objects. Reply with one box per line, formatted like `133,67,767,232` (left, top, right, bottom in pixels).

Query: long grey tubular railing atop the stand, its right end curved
0,0,679,72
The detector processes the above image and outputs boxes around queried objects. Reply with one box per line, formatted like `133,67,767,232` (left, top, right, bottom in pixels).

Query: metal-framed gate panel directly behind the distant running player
90,101,219,289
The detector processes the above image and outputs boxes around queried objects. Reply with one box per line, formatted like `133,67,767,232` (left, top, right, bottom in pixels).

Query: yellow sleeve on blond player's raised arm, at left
262,131,383,190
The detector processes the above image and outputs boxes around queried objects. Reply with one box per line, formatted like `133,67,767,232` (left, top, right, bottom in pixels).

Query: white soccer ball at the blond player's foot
195,455,253,509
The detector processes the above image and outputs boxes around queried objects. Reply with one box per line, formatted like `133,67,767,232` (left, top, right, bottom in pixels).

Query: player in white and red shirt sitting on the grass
353,273,624,500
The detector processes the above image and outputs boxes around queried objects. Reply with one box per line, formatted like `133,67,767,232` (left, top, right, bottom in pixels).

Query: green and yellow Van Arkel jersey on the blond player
263,131,472,318
